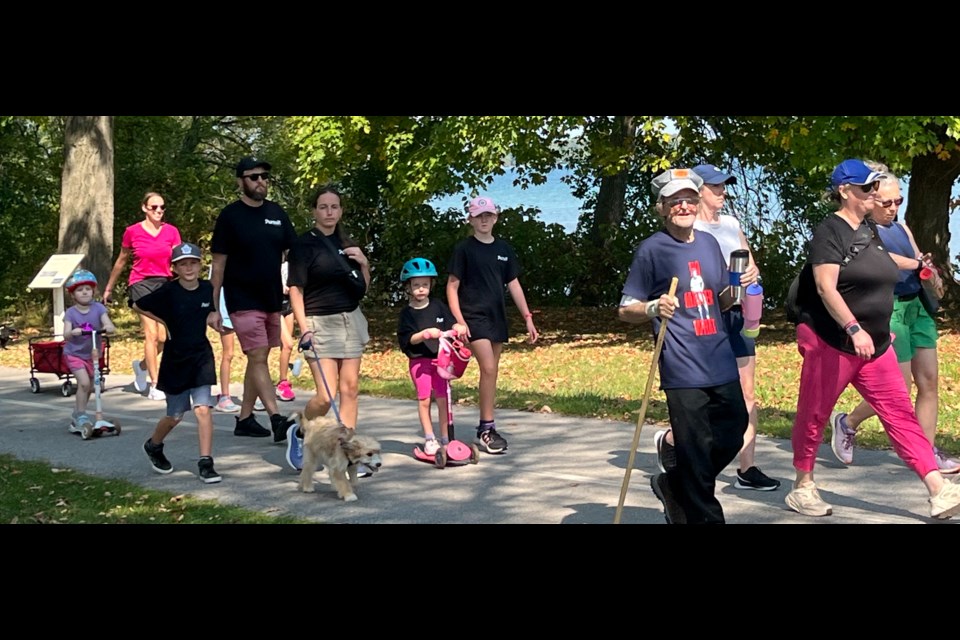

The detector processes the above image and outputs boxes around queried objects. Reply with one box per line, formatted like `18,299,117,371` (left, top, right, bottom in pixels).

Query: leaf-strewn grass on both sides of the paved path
0,308,960,522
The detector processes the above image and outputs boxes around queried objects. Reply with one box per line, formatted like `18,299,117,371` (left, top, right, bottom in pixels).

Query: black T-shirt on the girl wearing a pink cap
448,236,520,327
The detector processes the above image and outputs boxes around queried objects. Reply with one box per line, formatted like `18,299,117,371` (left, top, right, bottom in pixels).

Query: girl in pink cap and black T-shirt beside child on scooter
447,197,538,453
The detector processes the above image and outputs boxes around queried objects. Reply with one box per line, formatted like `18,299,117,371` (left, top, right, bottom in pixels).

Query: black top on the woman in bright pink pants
798,215,900,358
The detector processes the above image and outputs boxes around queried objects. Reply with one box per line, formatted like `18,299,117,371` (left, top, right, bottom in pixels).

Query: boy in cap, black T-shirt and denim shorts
133,242,221,484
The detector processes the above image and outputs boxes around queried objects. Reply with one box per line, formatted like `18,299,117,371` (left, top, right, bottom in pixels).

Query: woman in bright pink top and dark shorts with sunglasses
103,191,181,400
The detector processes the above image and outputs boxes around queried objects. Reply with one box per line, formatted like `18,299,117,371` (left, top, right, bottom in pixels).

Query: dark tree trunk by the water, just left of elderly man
574,116,637,307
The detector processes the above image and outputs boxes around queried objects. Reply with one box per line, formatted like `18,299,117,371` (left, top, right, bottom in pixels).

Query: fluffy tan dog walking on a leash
293,414,383,502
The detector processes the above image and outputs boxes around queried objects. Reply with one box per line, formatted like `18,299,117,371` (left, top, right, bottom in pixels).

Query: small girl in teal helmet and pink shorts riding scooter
397,258,466,455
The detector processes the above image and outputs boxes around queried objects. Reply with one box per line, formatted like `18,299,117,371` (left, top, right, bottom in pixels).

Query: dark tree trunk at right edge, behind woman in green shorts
904,153,960,300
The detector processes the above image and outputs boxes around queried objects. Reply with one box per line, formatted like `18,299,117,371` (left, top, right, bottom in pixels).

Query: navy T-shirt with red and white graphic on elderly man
623,231,740,389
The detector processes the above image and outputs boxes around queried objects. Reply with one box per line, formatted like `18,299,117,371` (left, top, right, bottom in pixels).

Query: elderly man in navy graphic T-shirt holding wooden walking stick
619,169,748,524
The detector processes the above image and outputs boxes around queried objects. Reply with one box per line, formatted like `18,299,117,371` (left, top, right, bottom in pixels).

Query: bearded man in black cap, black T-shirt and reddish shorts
207,157,297,442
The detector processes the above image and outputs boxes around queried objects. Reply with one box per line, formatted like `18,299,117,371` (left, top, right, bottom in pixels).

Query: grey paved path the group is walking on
0,367,935,524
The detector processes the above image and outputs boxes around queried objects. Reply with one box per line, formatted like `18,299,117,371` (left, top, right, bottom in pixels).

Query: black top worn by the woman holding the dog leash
286,229,362,316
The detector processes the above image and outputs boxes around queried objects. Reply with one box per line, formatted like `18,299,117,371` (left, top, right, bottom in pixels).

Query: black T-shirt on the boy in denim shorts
135,280,217,395
